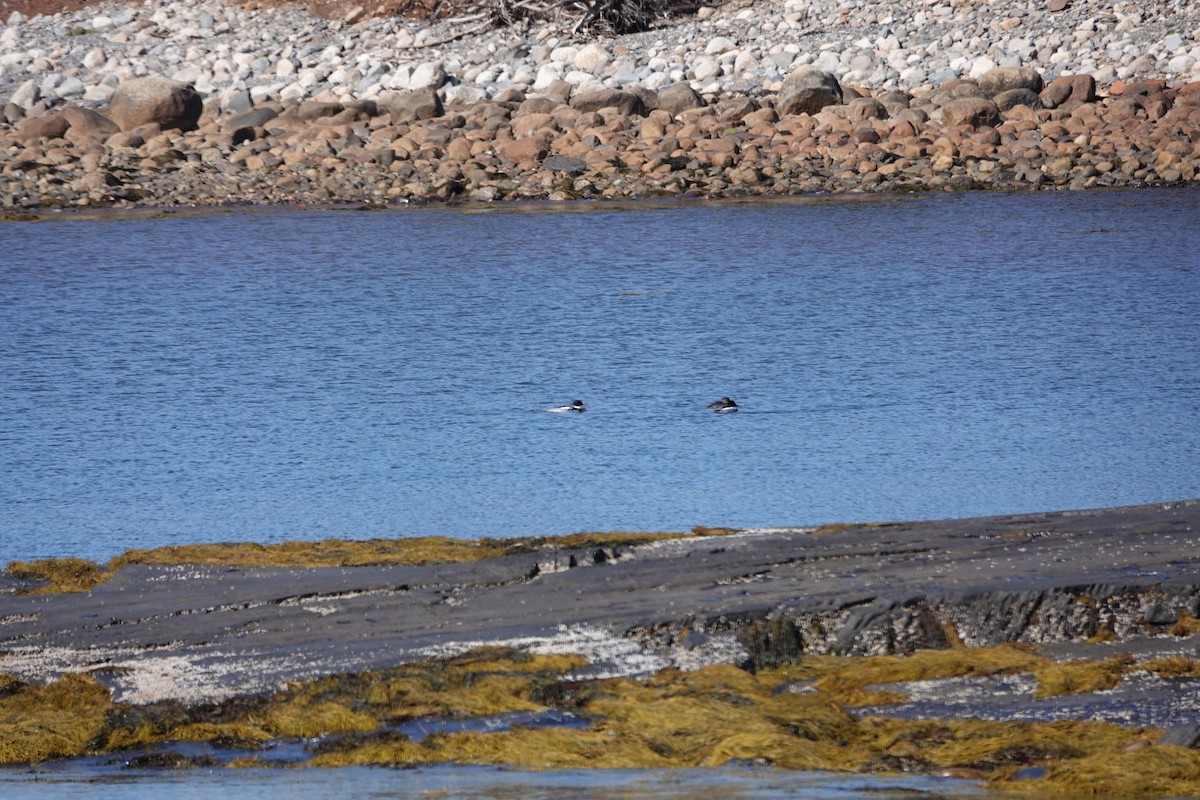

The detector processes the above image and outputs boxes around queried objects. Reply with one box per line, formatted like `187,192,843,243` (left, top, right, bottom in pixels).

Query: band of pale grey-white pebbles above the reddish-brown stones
0,0,1200,109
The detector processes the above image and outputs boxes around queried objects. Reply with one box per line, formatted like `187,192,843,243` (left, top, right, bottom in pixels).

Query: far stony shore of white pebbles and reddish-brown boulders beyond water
0,0,1200,213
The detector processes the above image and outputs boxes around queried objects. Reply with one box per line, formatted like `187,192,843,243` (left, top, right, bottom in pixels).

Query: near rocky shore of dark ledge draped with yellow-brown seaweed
0,500,1200,798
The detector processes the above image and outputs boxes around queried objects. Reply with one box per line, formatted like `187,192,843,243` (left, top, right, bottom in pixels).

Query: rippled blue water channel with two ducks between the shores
0,190,1200,564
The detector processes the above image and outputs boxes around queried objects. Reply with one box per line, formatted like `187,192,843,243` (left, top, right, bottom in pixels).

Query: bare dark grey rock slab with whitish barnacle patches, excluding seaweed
0,501,1200,705
